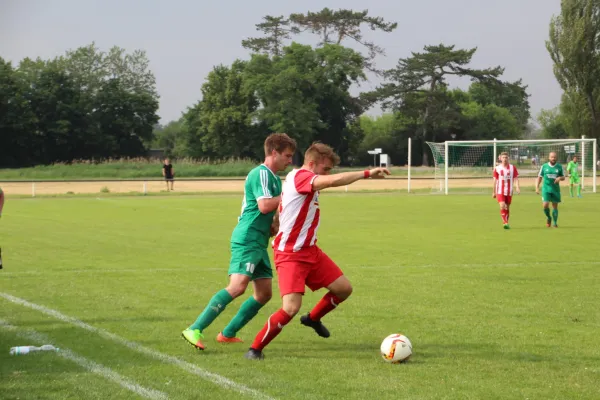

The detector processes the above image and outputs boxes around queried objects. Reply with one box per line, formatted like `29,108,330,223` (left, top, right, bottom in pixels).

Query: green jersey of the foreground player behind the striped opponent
231,164,281,248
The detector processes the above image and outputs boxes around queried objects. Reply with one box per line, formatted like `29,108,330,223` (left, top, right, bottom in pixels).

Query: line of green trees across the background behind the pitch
0,5,600,167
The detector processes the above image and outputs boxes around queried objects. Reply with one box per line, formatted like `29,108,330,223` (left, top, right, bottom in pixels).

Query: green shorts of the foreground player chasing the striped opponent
228,243,273,281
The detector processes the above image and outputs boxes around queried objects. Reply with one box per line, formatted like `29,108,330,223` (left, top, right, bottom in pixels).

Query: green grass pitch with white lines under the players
0,193,600,399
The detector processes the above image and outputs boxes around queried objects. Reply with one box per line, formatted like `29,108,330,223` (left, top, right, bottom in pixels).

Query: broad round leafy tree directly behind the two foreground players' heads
247,43,365,158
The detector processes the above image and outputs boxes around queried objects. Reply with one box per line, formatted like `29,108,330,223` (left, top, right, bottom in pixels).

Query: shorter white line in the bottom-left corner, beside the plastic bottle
0,319,168,400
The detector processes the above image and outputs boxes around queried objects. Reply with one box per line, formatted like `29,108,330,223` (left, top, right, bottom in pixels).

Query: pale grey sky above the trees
0,0,562,124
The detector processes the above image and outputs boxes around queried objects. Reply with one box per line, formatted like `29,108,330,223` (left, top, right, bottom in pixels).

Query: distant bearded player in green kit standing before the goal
535,152,565,228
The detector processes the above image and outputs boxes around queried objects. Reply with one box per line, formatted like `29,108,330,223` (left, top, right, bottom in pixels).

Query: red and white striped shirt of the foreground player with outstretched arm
273,169,320,252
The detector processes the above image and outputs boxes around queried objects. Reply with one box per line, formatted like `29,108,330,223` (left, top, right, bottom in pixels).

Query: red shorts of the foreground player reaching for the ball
275,246,344,296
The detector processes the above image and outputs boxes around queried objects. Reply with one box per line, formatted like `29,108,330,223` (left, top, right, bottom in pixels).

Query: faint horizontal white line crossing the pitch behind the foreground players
2,261,600,275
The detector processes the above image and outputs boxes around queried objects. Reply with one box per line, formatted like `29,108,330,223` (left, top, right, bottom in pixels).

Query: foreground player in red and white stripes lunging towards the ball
245,143,390,360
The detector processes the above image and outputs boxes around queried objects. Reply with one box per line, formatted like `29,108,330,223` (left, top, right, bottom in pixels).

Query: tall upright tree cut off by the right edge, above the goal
546,0,600,138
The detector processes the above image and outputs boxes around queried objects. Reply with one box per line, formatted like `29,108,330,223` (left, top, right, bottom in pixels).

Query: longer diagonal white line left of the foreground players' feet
0,292,274,400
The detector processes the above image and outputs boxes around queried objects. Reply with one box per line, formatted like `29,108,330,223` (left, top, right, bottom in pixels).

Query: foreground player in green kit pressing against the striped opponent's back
182,133,296,350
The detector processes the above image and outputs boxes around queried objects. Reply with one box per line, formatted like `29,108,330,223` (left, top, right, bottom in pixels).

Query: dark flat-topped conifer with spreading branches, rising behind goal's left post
364,44,503,164
